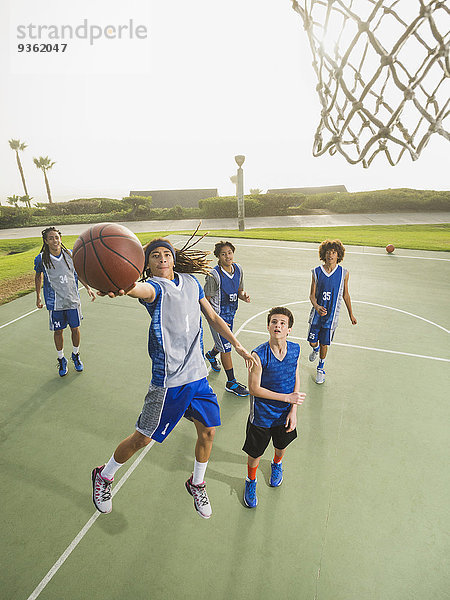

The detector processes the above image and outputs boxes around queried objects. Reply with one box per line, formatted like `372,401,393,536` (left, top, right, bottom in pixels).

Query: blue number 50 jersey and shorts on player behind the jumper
204,263,244,352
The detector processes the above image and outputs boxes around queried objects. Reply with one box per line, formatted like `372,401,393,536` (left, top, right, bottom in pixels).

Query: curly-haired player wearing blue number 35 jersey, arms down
307,240,356,384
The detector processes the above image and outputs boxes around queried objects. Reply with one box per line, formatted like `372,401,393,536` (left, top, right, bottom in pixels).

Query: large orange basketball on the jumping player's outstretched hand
72,223,144,293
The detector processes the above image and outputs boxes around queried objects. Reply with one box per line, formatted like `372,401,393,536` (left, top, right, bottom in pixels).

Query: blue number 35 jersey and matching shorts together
308,265,347,345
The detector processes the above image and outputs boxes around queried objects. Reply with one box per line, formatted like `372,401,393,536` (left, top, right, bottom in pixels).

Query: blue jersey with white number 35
309,265,347,330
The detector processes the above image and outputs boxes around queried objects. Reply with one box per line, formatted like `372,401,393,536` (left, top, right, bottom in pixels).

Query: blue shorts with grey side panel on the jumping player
136,377,220,442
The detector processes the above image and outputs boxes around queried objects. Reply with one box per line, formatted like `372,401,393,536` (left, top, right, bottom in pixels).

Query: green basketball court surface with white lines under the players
0,235,450,600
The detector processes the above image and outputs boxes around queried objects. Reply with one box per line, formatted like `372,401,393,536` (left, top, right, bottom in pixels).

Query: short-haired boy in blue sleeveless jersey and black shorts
242,306,305,508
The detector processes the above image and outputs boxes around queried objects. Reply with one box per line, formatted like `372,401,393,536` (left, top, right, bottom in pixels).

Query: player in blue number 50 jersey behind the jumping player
204,241,250,397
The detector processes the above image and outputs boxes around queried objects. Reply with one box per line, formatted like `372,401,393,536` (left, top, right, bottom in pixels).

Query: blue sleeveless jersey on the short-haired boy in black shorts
250,342,300,427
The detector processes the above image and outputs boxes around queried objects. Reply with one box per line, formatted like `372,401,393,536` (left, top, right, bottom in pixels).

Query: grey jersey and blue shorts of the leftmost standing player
34,250,83,331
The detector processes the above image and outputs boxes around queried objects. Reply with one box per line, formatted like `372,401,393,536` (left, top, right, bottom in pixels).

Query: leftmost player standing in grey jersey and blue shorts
34,227,95,377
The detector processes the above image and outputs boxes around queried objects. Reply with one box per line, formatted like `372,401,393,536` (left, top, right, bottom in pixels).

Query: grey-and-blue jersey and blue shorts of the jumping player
136,273,220,442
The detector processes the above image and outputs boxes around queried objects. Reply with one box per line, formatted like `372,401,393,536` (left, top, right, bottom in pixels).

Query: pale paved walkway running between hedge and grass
0,212,450,239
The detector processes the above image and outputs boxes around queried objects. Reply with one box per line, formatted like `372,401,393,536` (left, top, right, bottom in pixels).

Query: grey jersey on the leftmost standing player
34,250,81,310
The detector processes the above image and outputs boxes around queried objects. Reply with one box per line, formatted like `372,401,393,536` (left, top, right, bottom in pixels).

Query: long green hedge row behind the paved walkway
0,189,450,228
